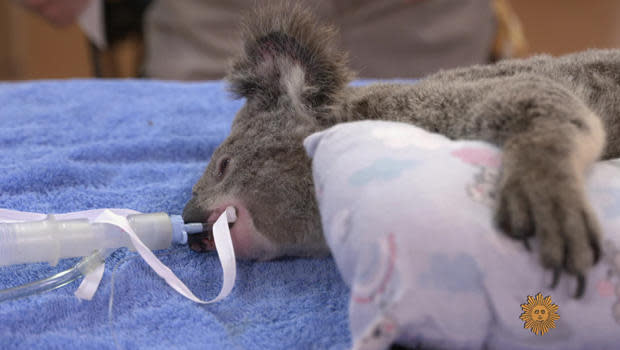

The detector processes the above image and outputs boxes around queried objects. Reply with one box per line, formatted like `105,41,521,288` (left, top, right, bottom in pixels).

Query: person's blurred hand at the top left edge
21,0,91,27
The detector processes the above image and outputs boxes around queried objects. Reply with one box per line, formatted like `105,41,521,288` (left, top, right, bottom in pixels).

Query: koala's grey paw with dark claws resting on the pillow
495,173,601,298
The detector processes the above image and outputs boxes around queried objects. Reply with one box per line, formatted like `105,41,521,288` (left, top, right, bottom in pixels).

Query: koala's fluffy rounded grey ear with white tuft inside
227,1,352,110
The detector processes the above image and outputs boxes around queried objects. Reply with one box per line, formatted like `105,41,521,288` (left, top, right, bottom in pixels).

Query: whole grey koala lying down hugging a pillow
183,3,620,297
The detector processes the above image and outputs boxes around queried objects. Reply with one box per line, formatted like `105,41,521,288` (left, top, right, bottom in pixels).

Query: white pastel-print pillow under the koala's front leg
304,121,620,349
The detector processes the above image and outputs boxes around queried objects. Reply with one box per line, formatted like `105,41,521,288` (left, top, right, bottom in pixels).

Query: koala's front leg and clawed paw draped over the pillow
471,78,605,297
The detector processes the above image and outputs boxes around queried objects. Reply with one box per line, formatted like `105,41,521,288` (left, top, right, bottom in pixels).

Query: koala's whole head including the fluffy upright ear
183,2,350,259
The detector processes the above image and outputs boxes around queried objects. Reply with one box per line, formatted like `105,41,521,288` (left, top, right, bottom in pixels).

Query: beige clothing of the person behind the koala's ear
144,0,496,80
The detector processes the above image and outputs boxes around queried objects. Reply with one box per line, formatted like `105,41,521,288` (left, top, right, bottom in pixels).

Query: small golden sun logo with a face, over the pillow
519,293,560,335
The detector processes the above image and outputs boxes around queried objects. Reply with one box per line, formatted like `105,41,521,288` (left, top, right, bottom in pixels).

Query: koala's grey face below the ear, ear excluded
183,105,327,259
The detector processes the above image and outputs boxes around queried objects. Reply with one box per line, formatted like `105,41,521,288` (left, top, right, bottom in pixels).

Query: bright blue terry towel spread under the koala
0,80,351,349
